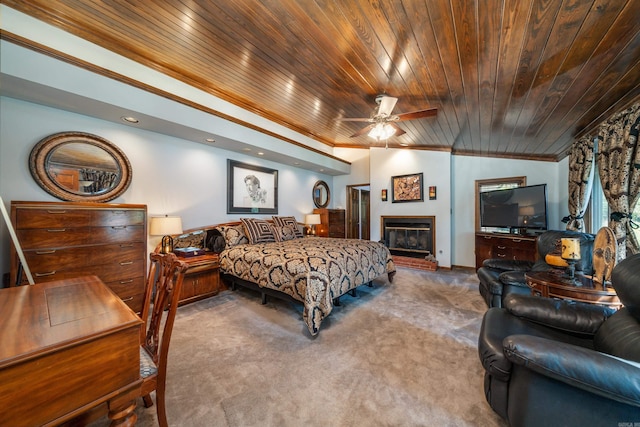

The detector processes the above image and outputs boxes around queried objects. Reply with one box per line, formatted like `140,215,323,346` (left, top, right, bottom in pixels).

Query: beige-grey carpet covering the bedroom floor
95,268,506,427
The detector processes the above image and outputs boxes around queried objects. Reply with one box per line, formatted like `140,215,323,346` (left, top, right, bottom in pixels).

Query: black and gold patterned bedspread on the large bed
220,237,396,335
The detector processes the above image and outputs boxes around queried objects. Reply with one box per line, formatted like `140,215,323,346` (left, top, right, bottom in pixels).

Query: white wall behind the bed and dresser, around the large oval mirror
0,97,333,280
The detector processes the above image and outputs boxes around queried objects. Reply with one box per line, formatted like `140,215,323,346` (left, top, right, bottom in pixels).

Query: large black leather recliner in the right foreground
478,254,640,427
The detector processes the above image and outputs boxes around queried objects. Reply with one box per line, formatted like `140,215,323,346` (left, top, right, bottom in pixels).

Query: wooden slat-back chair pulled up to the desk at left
140,253,188,427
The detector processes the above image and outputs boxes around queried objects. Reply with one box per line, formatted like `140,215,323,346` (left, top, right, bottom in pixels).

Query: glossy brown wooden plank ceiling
2,0,640,161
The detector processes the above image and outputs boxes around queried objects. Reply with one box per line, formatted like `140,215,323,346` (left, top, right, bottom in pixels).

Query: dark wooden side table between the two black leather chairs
525,271,622,309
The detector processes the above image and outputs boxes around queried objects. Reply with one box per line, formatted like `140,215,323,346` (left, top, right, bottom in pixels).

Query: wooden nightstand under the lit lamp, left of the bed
179,254,221,305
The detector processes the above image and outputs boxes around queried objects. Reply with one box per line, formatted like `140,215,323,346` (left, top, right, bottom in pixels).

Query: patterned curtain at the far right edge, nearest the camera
597,102,640,261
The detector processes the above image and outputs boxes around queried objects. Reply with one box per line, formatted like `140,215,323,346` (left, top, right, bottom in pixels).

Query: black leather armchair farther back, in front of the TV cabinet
477,230,595,307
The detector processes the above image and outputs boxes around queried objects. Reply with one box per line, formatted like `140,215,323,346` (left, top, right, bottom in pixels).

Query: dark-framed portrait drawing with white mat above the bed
227,159,278,214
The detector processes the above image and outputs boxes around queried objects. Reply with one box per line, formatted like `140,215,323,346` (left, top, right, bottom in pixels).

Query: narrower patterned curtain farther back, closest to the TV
562,135,594,232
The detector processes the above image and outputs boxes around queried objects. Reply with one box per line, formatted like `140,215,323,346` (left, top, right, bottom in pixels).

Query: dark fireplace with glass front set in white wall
381,216,436,259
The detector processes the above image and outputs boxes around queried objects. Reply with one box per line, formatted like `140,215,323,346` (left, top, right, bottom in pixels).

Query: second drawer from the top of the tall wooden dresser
16,225,144,250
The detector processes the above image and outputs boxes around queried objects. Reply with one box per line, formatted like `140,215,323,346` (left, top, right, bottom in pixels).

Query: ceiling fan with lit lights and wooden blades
341,95,438,141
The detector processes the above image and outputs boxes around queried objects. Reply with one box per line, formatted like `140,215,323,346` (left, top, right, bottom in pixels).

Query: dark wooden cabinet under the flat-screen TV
476,233,536,269
